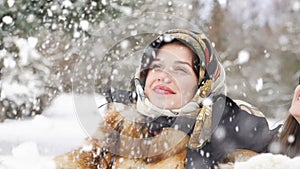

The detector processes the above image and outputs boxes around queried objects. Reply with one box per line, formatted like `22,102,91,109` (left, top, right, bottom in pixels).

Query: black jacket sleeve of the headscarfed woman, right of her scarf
187,95,279,169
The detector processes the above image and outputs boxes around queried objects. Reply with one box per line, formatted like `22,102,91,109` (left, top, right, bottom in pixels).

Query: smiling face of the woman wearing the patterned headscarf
145,42,198,109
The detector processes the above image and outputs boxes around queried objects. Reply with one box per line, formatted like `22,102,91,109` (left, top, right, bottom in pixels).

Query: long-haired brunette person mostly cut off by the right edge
279,83,300,157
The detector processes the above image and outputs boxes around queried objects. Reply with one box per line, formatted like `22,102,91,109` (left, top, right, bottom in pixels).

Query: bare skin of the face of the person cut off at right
289,85,300,123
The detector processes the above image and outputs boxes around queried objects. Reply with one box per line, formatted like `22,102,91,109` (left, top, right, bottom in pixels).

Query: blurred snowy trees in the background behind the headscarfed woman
0,0,300,120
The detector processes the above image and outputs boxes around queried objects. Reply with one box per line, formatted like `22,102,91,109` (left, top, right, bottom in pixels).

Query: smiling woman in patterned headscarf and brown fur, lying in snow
55,29,277,169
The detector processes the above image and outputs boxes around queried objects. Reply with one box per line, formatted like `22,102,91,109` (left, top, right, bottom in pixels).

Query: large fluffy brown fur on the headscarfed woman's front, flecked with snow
54,104,189,169
